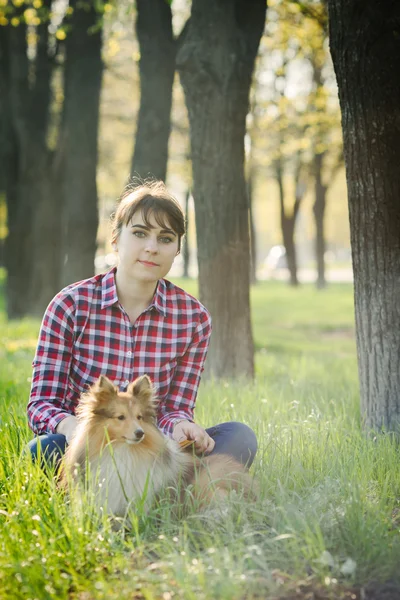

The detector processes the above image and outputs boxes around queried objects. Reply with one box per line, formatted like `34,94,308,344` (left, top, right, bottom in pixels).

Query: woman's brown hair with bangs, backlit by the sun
111,179,185,252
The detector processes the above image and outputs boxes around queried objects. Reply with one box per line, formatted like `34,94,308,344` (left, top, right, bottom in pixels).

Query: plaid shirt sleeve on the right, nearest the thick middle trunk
158,309,211,436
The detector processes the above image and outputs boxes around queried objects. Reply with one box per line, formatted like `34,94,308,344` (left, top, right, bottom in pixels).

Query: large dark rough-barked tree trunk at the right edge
329,0,400,431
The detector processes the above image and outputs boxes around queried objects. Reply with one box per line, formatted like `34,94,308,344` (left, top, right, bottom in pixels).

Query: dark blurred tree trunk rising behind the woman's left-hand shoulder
57,0,103,286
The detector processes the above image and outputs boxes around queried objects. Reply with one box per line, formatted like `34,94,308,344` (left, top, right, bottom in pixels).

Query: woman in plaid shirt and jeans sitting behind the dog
28,181,257,466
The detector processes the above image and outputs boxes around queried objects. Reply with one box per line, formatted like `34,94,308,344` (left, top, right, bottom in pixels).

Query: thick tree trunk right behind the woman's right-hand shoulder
177,0,266,377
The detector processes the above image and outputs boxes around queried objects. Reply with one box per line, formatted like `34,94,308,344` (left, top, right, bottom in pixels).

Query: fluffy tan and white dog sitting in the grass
62,375,253,517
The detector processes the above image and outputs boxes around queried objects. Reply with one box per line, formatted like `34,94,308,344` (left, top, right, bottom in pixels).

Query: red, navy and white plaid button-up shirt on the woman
28,269,211,434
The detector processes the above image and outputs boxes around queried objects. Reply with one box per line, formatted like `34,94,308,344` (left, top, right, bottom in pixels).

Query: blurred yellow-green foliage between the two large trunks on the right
254,0,341,181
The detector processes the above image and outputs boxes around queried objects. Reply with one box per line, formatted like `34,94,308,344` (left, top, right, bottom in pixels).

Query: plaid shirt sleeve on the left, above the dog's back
27,292,74,435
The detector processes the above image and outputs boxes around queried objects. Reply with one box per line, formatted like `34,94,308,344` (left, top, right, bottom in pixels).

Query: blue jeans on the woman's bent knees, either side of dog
28,421,257,467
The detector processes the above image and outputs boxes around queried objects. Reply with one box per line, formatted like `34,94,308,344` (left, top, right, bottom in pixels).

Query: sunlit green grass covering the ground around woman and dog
0,282,400,600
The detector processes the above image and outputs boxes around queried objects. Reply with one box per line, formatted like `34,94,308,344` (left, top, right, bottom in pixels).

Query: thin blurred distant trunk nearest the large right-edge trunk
313,153,326,289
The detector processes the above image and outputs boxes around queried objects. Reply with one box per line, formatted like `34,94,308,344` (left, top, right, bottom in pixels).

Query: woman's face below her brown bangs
114,212,178,282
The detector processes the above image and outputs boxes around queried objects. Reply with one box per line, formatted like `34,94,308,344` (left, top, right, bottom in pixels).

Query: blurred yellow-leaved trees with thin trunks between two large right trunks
252,0,345,288
